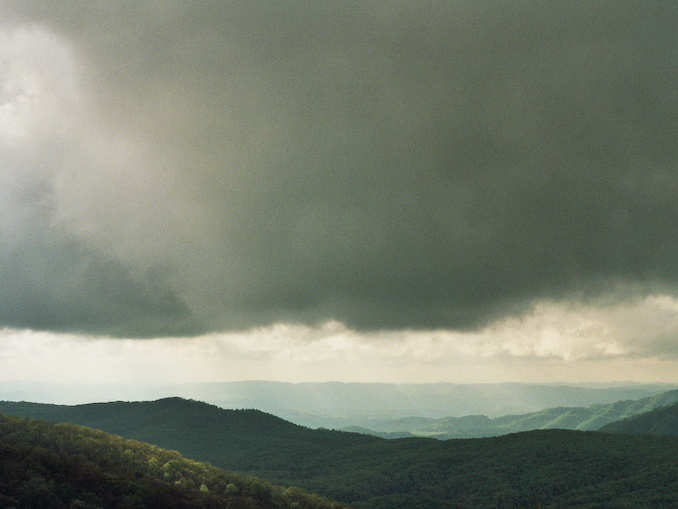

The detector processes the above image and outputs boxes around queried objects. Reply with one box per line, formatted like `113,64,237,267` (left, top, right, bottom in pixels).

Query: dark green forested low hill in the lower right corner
298,430,678,508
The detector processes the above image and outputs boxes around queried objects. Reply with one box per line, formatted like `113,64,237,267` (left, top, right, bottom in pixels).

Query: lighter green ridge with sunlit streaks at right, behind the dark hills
362,390,678,440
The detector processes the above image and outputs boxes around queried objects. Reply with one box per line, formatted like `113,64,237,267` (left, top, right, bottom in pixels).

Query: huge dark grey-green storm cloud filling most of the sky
0,1,678,335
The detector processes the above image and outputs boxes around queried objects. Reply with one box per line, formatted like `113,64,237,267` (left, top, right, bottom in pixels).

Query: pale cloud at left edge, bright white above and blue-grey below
0,27,193,335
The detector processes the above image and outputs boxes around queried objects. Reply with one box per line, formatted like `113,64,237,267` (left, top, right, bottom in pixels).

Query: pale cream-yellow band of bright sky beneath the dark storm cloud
0,296,678,385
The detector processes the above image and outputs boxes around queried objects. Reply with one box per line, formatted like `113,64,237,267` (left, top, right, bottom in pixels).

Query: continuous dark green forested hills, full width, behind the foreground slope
0,398,678,509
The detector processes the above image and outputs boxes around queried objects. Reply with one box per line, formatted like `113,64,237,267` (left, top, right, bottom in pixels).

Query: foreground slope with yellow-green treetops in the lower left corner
0,415,342,509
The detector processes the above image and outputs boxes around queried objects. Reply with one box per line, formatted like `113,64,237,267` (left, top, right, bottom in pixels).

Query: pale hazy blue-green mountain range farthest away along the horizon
0,381,678,429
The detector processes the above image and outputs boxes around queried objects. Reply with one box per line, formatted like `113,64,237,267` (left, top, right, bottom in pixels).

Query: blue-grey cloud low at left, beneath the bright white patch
0,167,195,336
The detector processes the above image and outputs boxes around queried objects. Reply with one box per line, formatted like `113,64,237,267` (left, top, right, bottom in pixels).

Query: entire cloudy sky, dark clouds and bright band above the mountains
0,0,678,383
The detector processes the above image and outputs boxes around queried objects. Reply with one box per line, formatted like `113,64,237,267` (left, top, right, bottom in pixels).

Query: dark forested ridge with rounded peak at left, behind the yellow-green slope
0,398,379,471
